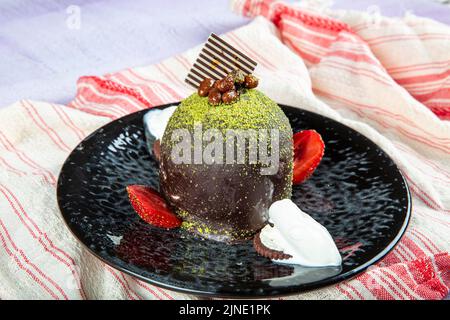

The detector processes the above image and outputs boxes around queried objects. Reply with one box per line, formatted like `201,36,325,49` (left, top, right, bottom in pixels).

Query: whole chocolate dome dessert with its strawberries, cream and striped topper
134,34,342,269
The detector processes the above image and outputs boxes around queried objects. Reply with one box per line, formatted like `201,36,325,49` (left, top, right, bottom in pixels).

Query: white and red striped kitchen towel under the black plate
0,1,450,299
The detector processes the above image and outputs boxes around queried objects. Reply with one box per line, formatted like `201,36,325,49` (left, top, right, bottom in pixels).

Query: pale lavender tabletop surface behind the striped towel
0,0,450,108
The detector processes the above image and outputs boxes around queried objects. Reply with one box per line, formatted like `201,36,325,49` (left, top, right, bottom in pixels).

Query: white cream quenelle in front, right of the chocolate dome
260,199,342,267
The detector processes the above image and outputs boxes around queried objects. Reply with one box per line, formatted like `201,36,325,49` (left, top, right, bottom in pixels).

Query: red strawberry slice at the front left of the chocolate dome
127,185,181,229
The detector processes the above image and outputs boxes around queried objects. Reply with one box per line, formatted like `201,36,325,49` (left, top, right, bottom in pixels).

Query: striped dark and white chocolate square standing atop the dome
185,33,256,89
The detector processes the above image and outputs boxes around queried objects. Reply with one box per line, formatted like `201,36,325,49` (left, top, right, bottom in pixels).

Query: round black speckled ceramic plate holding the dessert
57,105,411,297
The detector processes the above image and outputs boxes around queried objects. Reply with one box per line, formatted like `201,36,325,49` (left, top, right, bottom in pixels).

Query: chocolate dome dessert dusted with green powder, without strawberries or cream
160,78,293,242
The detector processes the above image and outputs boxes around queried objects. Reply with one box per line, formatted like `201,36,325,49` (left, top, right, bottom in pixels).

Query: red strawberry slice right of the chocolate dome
292,130,325,184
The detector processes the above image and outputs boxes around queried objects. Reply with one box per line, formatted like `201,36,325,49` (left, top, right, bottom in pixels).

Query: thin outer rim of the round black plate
56,101,412,298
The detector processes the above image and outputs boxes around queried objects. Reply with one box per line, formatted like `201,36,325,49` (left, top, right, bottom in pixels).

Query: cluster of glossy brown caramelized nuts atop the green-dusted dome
198,69,258,106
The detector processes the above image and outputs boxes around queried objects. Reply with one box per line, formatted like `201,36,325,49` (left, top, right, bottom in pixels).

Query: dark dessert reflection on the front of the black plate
114,221,341,286
